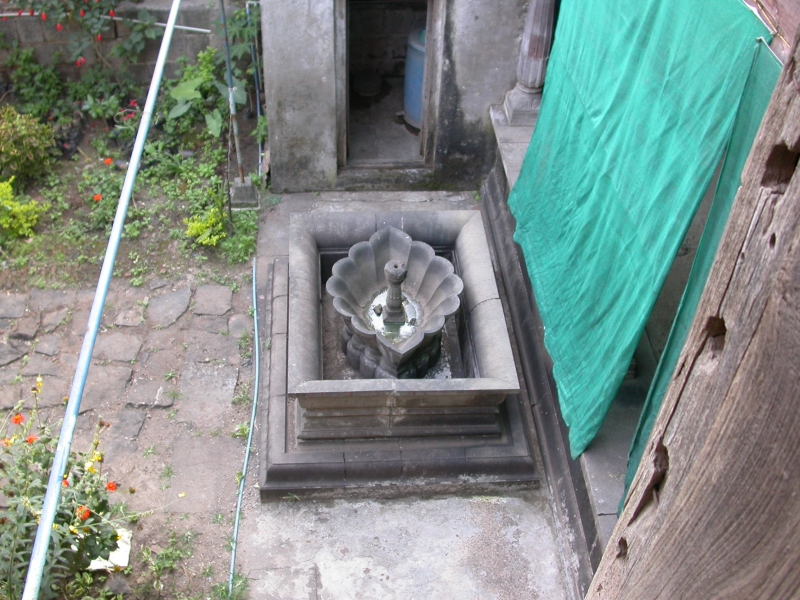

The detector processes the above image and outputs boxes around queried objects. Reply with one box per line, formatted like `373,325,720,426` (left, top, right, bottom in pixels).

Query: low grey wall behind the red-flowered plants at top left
0,0,219,83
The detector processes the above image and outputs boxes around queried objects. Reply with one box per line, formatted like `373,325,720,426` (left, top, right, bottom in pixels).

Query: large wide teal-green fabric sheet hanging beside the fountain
508,0,767,457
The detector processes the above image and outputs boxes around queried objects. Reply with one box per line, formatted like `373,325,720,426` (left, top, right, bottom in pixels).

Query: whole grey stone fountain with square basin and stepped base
260,210,538,498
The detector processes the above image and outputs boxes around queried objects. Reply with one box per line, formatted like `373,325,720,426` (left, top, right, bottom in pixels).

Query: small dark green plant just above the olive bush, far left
6,48,64,120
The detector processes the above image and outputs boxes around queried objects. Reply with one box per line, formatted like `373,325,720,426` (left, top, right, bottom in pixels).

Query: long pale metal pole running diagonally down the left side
22,0,181,600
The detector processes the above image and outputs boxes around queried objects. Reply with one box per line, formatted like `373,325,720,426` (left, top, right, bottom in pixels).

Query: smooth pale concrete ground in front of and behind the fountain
236,192,568,600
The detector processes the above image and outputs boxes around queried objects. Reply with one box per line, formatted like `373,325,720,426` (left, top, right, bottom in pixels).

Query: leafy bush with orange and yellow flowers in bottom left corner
0,392,130,600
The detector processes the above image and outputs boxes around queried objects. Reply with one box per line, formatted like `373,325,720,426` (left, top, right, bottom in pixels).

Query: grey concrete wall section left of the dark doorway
261,0,337,191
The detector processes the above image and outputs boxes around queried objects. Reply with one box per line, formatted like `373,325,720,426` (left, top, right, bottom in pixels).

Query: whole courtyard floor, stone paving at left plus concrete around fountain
0,192,570,600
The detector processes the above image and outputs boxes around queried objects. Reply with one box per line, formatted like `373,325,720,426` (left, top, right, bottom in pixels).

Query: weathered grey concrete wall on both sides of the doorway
262,0,527,191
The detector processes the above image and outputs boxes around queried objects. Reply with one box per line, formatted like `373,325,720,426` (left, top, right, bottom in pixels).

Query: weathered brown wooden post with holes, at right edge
586,31,800,600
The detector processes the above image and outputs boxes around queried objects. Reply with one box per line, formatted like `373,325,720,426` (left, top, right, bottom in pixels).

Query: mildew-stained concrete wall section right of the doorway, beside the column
433,0,528,189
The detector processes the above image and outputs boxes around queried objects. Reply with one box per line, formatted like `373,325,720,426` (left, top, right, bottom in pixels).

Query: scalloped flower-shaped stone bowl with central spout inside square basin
326,227,464,379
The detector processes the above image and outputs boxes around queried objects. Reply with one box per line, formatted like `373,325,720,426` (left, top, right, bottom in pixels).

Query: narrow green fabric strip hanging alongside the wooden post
620,40,781,508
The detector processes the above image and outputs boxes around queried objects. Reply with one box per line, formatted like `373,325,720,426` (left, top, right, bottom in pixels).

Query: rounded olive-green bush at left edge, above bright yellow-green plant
0,105,55,187
